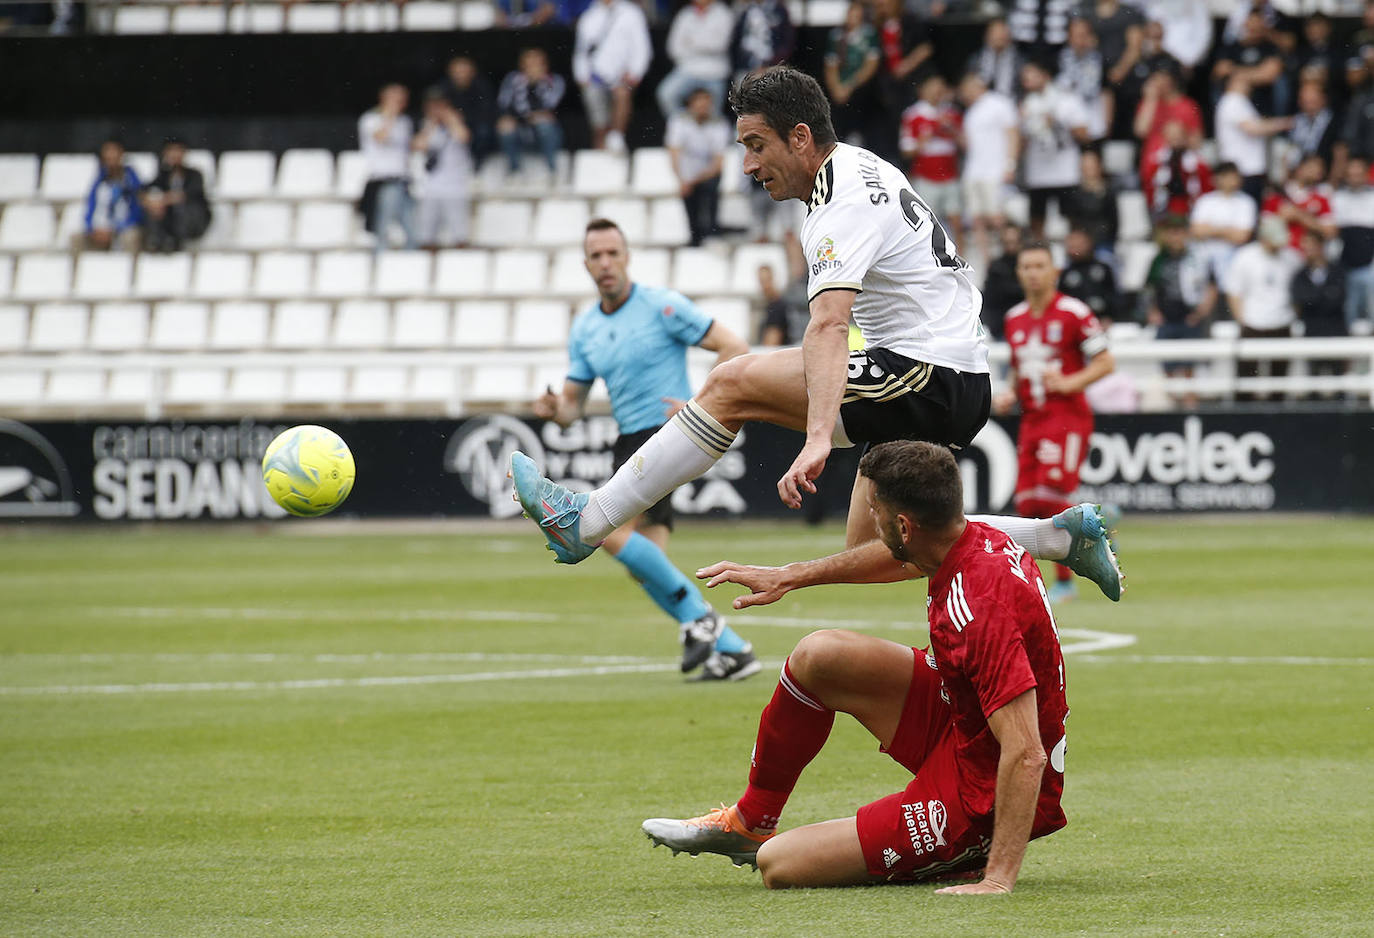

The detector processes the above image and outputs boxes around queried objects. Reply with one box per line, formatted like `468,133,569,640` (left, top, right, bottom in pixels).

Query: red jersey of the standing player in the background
1006,293,1107,416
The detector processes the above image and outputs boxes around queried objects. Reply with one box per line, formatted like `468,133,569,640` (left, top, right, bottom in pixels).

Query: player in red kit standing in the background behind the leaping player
992,243,1116,603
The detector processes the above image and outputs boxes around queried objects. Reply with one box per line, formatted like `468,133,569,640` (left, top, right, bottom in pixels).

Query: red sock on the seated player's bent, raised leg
736,662,835,830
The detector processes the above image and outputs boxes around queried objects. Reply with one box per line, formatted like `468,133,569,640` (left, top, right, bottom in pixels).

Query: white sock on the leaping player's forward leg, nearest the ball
578,400,735,544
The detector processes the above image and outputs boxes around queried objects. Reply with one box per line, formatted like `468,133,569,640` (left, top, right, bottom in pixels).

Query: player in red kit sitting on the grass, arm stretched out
643,441,1069,894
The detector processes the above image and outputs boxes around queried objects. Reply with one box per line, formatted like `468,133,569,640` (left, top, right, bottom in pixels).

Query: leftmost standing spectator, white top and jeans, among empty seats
357,84,415,251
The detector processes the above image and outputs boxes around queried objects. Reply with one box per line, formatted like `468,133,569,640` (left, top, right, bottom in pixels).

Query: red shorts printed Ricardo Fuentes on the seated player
857,648,992,882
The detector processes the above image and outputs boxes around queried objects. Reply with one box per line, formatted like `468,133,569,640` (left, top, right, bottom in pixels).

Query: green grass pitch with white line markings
0,518,1374,938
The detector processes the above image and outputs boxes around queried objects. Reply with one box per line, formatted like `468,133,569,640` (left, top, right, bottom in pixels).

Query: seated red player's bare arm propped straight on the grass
936,688,1048,895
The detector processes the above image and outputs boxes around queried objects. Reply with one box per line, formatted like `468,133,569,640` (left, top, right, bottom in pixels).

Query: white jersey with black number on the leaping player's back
801,143,988,374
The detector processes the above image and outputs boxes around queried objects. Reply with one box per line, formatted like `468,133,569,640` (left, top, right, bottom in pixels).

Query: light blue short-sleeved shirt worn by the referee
567,283,712,434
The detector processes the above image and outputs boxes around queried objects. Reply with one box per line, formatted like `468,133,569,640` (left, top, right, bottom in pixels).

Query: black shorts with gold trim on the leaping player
840,349,992,449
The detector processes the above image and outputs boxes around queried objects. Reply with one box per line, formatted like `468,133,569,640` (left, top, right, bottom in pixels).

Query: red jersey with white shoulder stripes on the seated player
927,522,1069,836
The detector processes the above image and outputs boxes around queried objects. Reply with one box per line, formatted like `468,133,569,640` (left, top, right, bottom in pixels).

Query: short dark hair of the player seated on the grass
859,439,963,529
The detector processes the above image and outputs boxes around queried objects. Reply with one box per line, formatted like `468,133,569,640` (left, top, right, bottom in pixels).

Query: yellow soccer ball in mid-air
262,424,354,518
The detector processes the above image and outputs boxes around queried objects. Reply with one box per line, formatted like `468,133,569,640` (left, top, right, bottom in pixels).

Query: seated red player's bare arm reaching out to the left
697,541,926,608
